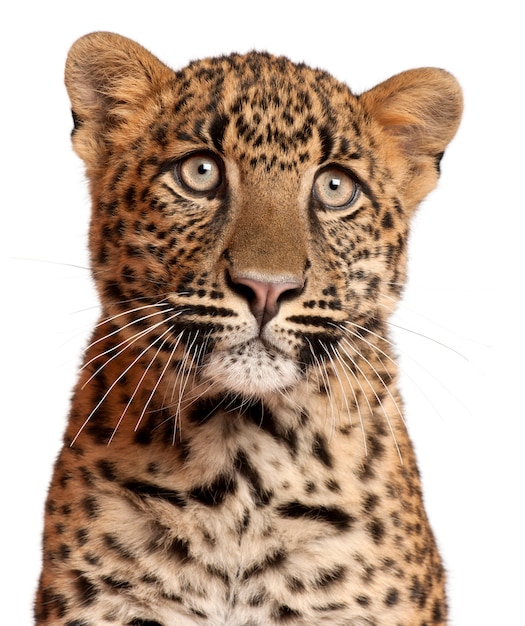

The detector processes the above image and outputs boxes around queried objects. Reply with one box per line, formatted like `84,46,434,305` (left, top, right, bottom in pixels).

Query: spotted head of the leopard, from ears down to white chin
67,33,457,397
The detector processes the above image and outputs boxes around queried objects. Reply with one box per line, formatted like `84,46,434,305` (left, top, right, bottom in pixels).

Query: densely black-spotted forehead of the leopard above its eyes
141,52,362,172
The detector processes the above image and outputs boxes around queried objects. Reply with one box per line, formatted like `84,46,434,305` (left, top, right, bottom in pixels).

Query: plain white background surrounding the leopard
0,0,525,626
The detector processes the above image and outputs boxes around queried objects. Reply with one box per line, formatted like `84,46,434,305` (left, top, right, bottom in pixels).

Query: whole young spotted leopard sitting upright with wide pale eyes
34,32,462,626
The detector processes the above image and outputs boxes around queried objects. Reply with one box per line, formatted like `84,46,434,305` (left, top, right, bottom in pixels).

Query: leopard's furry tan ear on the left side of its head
65,32,173,166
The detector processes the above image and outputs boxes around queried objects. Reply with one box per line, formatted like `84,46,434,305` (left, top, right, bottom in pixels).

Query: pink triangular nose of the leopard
232,276,303,328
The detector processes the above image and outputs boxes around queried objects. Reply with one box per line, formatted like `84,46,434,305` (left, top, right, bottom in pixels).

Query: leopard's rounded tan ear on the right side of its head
360,68,463,156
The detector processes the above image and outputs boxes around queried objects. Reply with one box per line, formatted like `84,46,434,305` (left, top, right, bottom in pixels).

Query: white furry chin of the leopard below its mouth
201,339,300,398
